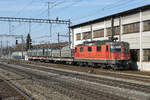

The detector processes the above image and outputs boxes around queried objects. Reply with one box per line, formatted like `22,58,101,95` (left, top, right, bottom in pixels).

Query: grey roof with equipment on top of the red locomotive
77,40,126,46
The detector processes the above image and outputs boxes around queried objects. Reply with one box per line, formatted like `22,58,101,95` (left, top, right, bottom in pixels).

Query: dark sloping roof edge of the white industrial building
70,4,150,28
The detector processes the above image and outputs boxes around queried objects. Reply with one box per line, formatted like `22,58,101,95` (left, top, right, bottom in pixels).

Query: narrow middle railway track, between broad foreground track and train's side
11,64,150,93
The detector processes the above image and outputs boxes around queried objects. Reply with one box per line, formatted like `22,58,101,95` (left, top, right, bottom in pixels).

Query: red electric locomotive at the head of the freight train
74,40,130,69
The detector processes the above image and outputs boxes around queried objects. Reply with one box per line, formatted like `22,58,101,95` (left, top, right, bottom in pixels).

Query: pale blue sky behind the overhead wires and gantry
0,0,150,45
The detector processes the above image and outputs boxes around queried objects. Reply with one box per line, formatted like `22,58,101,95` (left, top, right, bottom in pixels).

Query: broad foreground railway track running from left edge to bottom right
0,64,129,100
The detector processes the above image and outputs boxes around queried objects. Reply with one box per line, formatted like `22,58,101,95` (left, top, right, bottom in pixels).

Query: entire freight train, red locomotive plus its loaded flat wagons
28,40,130,70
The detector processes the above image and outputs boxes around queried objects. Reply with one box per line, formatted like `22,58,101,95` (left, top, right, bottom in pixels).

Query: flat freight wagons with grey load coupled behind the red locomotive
28,46,74,63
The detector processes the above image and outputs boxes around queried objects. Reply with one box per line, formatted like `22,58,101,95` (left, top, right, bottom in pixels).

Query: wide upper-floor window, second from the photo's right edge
123,22,140,34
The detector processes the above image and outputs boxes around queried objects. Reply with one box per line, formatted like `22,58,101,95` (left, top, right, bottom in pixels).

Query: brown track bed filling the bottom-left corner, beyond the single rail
0,78,33,100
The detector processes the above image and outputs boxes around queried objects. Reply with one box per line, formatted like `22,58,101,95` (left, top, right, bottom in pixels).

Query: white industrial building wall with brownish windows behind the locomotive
71,5,150,70
